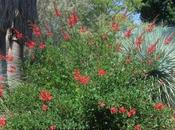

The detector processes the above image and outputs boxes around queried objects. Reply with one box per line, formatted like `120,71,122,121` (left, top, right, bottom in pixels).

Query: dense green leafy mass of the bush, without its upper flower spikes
1,30,173,130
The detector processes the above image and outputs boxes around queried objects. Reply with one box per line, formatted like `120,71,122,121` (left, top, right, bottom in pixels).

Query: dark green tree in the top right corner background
139,0,175,25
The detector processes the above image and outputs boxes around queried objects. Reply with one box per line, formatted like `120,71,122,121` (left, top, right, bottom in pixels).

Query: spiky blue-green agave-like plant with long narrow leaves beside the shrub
118,25,175,106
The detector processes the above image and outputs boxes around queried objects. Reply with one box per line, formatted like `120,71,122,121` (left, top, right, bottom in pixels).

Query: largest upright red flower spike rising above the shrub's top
68,9,78,27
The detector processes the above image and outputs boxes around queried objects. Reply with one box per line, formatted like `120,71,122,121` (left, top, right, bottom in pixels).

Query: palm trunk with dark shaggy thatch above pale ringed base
0,0,37,87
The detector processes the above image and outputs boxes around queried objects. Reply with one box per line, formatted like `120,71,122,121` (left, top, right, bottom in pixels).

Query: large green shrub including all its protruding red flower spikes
0,0,174,130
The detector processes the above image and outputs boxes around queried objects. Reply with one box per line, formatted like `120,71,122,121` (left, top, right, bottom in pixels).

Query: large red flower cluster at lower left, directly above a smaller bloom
40,90,52,102
